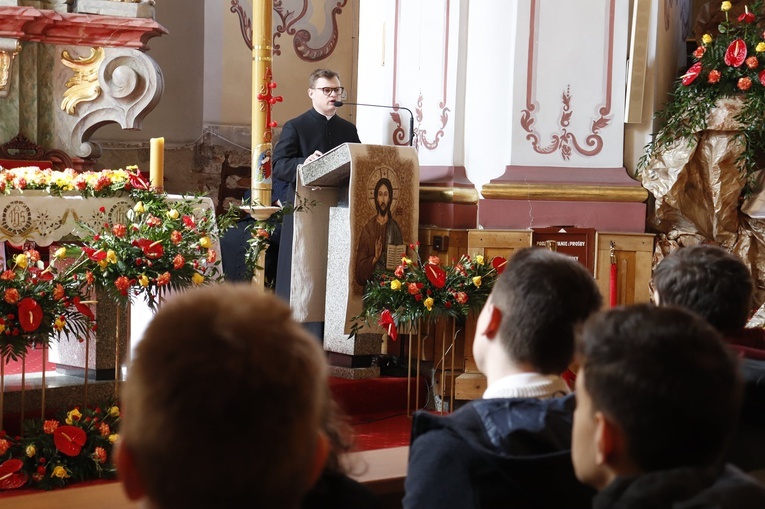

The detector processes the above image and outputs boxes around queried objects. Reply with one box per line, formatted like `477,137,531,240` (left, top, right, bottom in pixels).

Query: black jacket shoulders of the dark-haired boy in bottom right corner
593,466,765,509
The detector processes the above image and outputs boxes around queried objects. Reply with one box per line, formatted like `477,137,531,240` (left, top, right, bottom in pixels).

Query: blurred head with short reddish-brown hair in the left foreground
117,283,329,509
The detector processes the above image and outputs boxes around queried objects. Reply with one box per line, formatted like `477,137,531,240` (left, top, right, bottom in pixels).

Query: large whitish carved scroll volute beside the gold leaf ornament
57,48,164,158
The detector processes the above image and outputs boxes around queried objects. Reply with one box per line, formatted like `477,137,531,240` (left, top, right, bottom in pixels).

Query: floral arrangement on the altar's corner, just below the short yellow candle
74,185,236,309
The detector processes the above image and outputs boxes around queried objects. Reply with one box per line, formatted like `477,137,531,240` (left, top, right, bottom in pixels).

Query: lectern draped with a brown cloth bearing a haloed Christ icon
290,143,419,378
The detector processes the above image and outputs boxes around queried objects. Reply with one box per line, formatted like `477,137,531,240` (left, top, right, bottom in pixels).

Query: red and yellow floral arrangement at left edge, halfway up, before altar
0,248,96,360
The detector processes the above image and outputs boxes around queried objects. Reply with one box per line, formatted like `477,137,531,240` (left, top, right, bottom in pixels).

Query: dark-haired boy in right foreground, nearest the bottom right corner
571,305,765,509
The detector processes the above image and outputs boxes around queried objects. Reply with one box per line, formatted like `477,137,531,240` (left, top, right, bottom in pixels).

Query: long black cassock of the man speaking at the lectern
272,108,361,302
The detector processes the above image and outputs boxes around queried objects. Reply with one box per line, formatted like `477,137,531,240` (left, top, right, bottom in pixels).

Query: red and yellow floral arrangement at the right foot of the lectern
351,243,507,340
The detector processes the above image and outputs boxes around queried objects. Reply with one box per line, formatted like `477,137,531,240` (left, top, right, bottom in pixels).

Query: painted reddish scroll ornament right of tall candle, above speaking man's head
273,0,348,62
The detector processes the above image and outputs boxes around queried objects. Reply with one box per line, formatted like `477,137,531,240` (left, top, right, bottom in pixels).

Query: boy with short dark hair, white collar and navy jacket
404,248,602,509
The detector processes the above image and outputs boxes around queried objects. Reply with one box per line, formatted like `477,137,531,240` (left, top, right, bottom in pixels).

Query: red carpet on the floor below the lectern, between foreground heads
329,377,427,451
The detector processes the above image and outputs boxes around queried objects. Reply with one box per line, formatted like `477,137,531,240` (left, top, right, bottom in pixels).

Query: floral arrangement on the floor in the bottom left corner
0,405,120,490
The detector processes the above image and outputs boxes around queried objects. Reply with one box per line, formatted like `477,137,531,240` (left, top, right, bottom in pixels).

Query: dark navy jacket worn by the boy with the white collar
404,395,595,509
